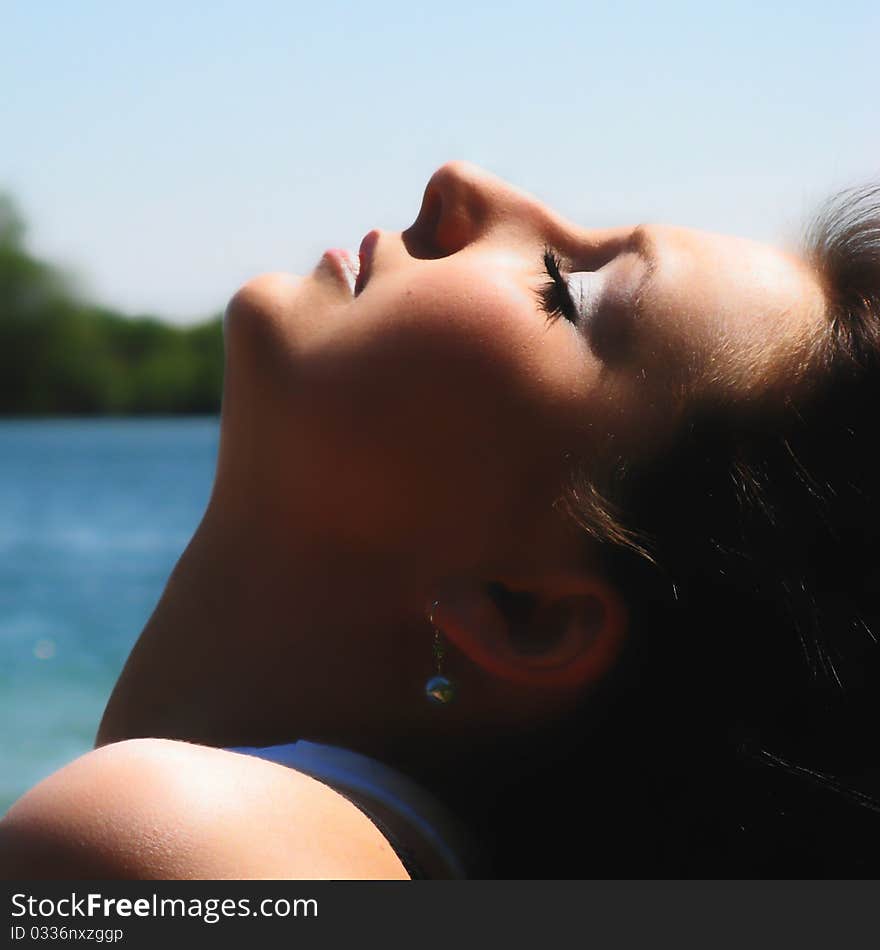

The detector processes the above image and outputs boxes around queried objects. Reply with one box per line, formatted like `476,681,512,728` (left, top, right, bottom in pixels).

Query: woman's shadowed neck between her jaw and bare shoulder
97,505,572,813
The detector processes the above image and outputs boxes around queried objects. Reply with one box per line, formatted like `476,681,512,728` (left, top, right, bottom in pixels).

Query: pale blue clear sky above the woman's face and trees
0,0,880,322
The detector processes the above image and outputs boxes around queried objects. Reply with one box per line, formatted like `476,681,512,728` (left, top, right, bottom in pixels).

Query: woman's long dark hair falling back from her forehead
484,185,880,877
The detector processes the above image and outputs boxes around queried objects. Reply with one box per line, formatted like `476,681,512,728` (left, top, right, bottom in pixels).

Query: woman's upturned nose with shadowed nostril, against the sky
404,161,540,257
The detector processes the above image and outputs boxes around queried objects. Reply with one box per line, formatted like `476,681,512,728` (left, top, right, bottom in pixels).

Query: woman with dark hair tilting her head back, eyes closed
0,162,880,878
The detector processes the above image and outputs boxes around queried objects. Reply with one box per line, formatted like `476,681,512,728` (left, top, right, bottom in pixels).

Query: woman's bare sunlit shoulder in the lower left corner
0,739,407,880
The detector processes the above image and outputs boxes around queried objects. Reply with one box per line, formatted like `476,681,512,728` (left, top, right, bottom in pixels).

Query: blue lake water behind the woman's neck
0,418,219,814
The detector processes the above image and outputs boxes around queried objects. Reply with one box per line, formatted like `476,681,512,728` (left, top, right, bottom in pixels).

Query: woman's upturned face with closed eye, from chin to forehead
217,162,823,564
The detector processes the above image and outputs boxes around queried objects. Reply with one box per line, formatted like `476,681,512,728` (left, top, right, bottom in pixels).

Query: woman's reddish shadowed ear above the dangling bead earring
431,574,628,689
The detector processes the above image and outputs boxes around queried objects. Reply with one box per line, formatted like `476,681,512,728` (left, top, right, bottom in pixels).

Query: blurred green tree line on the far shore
0,194,223,415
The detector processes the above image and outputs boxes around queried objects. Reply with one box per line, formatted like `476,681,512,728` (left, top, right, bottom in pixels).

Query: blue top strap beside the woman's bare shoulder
229,739,477,879
